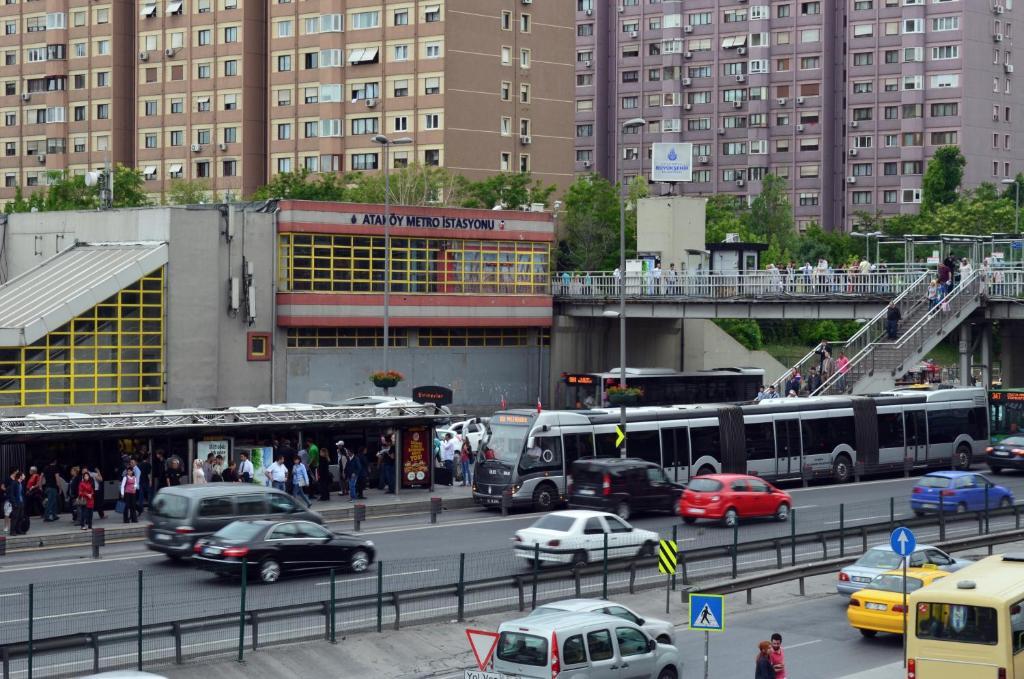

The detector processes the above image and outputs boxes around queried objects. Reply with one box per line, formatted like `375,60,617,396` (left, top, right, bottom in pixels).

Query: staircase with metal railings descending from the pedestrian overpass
812,272,983,395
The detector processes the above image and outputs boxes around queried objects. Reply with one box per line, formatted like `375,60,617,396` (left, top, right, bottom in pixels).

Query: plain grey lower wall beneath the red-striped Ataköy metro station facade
279,346,550,415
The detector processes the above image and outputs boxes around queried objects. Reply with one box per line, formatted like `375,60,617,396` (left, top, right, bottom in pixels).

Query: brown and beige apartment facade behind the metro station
0,0,574,200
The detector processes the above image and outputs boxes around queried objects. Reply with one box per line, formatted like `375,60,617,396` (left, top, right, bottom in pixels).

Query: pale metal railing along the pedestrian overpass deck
551,265,925,301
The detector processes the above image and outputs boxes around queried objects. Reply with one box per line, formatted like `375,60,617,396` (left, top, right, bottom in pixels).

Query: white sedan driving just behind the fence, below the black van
512,509,657,565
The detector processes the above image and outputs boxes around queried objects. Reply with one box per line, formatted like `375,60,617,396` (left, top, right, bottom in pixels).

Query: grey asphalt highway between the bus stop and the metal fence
0,467,1024,652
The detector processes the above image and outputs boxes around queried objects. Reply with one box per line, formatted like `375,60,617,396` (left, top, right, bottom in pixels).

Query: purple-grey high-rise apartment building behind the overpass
575,0,1024,228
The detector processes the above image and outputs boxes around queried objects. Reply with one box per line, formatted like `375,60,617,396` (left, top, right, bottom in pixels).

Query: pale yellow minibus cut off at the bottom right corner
906,553,1024,679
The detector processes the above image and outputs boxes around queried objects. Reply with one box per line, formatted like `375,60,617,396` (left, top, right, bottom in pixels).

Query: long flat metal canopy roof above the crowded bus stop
0,404,452,440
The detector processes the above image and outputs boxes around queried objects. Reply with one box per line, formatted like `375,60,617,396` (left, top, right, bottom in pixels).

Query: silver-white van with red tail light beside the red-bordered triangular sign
490,612,683,679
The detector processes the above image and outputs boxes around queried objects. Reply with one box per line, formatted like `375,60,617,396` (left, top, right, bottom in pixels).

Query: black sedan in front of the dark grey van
193,521,375,583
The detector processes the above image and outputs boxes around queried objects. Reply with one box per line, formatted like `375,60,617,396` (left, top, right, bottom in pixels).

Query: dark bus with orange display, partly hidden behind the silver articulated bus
559,368,765,411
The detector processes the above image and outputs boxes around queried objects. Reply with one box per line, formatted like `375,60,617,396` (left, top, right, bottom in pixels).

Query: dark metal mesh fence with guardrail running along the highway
0,498,1020,679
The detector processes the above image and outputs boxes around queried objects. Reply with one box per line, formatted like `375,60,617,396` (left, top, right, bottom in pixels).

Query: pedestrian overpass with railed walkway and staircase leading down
552,264,1024,394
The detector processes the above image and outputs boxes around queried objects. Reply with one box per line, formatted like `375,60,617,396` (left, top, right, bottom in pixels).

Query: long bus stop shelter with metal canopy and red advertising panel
0,401,452,499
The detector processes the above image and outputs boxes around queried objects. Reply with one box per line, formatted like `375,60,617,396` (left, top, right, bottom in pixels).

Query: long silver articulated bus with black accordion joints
473,387,988,511
